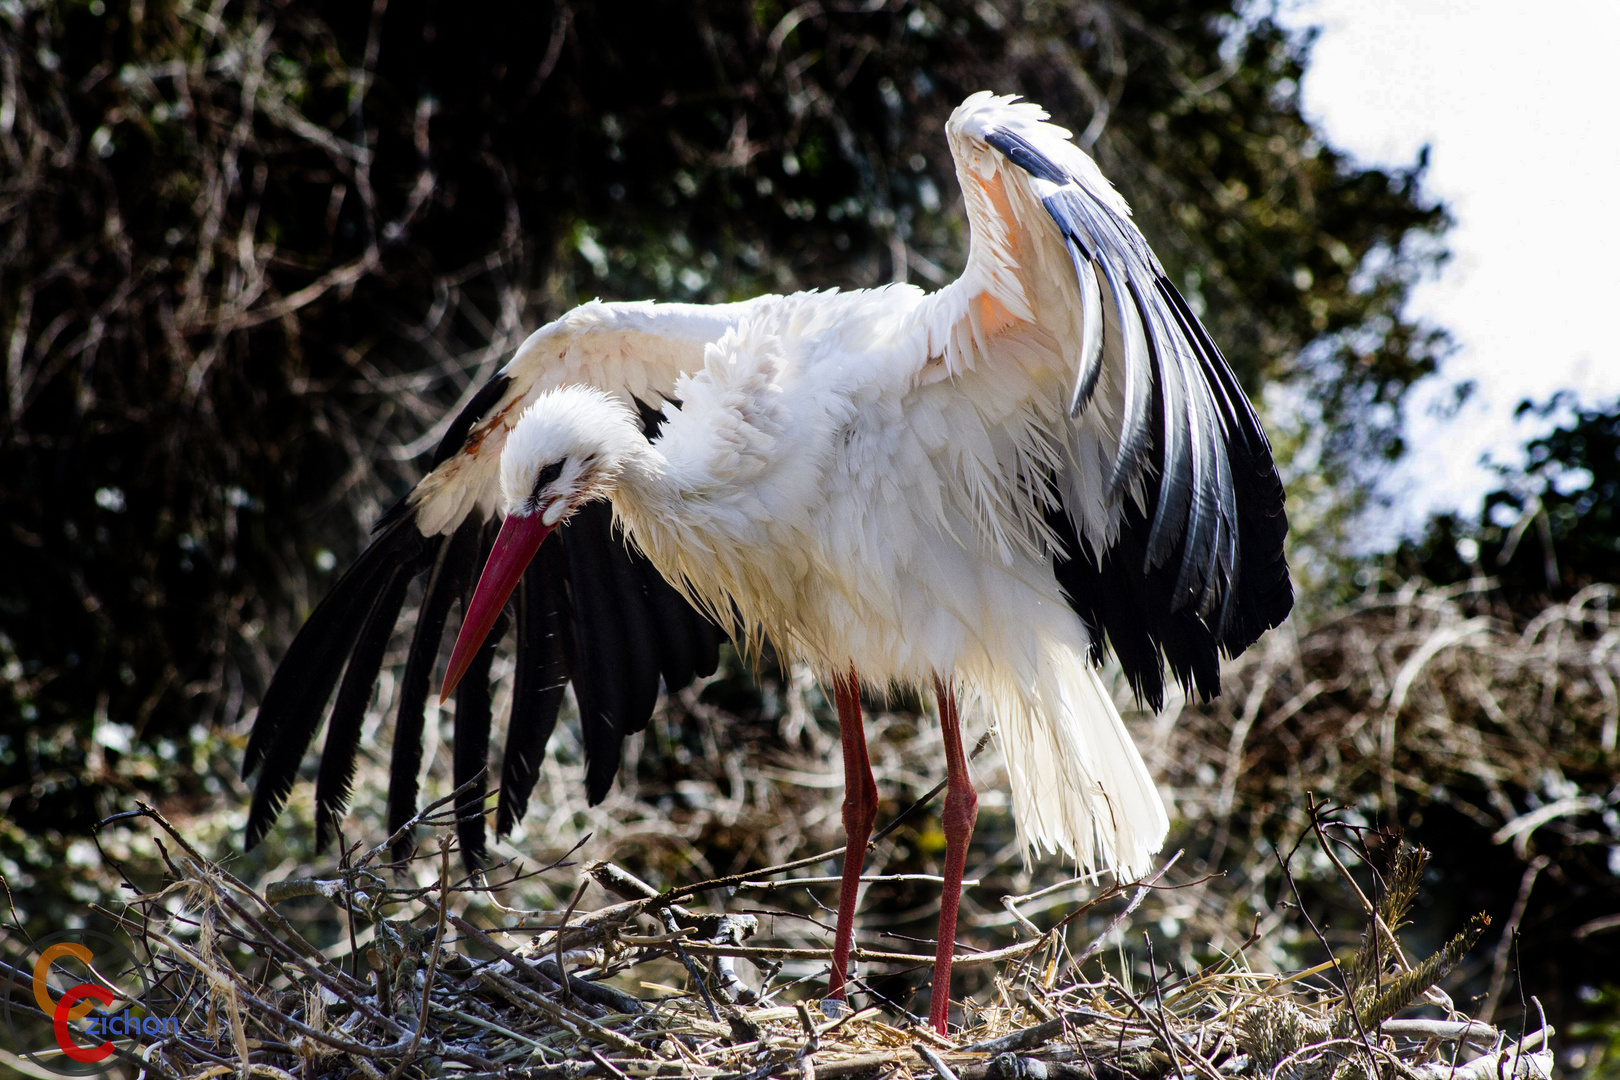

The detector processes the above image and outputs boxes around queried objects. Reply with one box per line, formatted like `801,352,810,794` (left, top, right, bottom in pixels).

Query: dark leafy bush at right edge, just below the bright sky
1396,393,1620,610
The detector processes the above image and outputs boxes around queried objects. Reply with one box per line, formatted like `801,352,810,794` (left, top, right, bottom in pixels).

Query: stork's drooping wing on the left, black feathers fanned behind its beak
243,303,761,860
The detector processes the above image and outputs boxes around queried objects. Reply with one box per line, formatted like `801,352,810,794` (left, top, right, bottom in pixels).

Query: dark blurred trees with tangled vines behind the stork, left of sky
0,0,1447,836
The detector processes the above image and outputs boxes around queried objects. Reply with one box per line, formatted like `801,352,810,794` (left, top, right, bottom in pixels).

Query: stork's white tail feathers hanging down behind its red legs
980,643,1170,879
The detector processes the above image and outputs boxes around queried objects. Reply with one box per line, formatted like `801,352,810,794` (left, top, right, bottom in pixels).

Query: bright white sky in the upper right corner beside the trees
1286,0,1620,540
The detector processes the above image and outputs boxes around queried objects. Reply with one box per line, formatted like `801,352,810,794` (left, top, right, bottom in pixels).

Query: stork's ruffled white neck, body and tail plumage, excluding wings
567,297,1168,873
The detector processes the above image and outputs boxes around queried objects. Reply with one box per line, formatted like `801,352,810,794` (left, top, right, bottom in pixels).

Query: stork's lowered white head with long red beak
439,387,646,701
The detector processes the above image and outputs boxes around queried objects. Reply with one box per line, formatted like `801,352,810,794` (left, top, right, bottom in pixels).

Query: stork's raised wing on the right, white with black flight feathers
930,94,1293,708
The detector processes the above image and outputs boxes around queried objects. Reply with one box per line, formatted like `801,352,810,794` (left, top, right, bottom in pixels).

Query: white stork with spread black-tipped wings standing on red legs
245,92,1293,1031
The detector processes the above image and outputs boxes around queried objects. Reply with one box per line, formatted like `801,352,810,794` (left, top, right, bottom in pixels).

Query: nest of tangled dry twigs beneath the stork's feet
63,795,1552,1080
